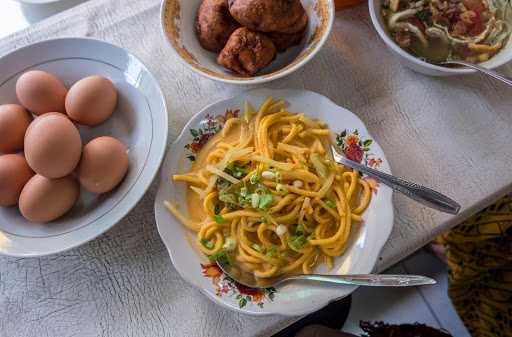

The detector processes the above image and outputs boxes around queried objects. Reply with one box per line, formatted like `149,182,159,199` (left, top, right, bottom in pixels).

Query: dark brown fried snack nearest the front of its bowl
217,27,277,76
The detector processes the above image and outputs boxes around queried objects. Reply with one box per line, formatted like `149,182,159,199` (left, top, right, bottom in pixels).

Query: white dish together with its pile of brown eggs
0,39,167,256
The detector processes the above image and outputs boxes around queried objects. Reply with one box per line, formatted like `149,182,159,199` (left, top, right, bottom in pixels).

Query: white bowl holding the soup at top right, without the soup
368,0,512,76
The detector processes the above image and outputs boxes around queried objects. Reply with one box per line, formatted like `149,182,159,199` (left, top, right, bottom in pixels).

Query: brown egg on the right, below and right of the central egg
78,137,128,193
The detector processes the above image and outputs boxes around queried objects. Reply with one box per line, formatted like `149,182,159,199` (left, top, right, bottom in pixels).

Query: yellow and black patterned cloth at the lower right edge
439,196,512,337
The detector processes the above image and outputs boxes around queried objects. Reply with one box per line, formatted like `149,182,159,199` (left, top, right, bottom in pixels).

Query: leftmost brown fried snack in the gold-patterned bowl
196,0,240,52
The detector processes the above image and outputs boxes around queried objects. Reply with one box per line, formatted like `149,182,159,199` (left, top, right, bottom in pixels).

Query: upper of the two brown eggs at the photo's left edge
0,104,32,153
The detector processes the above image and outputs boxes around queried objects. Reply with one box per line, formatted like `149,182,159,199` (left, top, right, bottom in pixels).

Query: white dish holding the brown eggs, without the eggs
0,38,168,256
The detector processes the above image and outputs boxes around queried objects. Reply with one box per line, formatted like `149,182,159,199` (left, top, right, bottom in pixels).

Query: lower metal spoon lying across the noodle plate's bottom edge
217,259,436,288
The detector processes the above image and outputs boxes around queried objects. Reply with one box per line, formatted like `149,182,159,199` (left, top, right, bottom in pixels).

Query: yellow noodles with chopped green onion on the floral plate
165,97,372,278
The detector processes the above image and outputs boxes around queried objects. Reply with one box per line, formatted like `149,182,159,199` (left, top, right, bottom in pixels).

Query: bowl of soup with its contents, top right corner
369,0,512,76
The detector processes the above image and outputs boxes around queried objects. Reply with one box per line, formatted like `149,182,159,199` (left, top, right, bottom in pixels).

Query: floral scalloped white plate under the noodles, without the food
155,89,393,316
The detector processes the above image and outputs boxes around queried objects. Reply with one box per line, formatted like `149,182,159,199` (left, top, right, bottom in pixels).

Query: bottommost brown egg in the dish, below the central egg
19,174,80,222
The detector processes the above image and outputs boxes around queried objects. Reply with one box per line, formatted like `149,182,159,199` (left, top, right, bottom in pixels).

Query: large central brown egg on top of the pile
25,112,82,178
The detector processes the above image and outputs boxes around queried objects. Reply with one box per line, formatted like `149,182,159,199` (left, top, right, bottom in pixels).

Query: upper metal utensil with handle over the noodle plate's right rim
331,146,460,214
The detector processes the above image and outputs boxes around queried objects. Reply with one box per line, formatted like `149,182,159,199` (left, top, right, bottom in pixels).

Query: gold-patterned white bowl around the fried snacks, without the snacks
161,0,334,84
